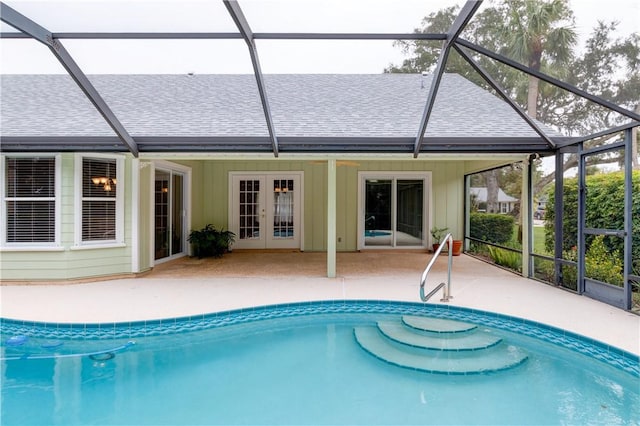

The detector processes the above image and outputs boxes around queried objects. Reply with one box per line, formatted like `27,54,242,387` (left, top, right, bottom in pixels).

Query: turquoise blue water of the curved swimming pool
0,301,640,425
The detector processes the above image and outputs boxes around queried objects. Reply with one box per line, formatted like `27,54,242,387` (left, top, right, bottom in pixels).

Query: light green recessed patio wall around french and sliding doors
179,160,478,251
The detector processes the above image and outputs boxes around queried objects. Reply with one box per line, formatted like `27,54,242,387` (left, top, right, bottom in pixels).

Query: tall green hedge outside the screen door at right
545,171,640,272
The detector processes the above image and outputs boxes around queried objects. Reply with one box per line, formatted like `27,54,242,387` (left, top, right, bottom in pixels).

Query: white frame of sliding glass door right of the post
357,171,433,250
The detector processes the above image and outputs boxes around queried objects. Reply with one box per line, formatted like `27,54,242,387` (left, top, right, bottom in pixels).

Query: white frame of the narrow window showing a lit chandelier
72,153,126,250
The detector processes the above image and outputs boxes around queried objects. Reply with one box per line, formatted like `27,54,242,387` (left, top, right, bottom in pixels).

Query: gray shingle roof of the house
0,74,557,138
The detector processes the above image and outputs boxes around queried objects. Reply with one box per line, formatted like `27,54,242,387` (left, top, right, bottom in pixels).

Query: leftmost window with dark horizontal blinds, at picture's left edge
2,155,59,246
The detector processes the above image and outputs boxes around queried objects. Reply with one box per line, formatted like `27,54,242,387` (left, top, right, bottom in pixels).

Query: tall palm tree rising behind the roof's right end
500,0,577,118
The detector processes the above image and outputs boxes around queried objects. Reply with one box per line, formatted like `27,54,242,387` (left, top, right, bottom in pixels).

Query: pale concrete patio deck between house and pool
0,251,640,355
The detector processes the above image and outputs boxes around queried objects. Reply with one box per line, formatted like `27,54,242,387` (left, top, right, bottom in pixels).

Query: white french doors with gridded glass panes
229,172,302,249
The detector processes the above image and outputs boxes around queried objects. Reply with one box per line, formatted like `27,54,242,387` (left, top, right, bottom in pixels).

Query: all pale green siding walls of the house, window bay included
0,153,524,281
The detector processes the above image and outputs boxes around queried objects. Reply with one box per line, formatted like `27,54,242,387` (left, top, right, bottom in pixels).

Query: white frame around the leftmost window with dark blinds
0,153,63,251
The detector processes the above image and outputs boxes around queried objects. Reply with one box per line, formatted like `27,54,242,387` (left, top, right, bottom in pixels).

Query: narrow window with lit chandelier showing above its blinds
76,156,123,245
